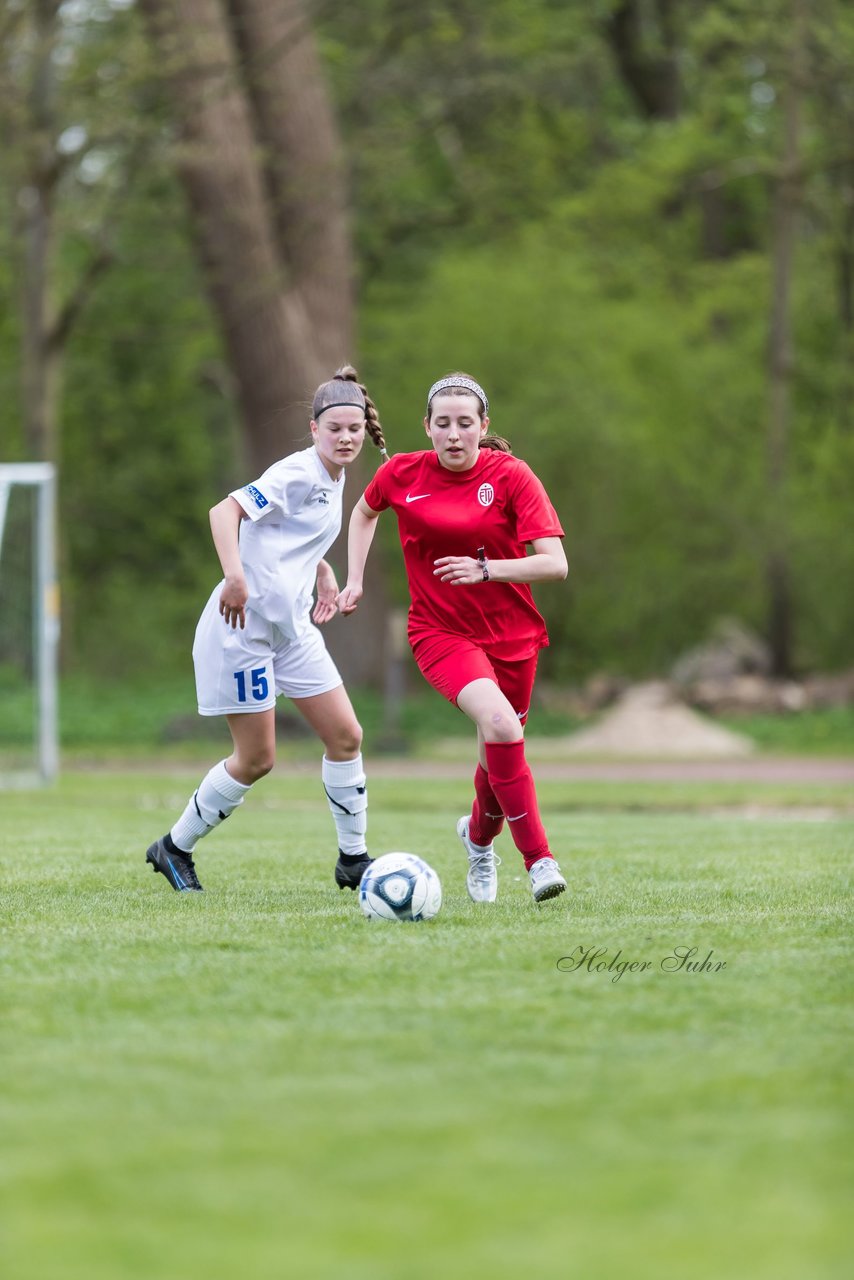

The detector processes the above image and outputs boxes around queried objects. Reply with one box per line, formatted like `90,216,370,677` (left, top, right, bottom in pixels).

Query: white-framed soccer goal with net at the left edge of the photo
0,462,59,787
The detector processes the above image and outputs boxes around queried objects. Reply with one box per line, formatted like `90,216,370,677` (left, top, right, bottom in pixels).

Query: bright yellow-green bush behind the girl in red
362,212,854,677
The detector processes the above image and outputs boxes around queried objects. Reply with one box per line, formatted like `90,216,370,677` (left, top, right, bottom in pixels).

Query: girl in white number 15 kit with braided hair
146,365,387,892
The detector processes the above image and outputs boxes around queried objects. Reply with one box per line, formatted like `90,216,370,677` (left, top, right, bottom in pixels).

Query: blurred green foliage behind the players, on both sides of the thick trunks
0,0,854,677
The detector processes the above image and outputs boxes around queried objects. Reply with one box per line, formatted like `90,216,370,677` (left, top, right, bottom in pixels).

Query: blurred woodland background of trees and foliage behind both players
0,0,854,744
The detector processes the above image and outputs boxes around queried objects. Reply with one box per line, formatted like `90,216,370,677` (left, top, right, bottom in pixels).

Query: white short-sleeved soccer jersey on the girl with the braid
232,445,344,639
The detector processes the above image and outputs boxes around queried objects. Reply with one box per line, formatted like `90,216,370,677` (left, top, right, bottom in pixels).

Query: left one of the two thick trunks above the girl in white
142,0,316,472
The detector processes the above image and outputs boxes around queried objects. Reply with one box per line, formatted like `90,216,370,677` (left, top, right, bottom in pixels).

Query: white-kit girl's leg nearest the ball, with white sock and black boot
292,685,371,890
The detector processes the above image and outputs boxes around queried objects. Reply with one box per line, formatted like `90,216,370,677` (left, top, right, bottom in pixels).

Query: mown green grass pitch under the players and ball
0,768,854,1280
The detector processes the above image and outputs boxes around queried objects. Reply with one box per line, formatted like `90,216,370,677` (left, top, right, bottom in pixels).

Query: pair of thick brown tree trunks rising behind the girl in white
141,0,385,684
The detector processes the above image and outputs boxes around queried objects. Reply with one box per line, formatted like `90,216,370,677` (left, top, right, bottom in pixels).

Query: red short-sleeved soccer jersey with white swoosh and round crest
365,449,563,662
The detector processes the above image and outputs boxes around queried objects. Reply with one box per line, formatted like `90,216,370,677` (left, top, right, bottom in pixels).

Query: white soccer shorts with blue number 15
193,582,343,716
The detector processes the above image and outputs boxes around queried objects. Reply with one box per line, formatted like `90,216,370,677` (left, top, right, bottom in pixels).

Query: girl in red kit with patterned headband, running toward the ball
338,374,566,902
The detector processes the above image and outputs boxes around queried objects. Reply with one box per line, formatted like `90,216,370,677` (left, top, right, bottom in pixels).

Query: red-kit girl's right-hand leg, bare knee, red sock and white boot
457,678,566,902
